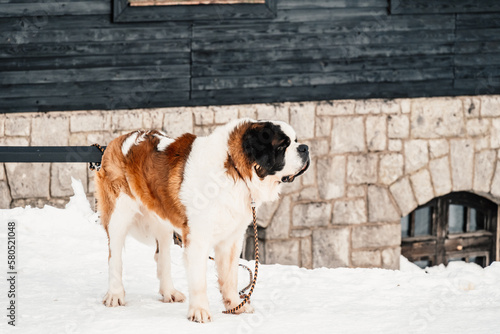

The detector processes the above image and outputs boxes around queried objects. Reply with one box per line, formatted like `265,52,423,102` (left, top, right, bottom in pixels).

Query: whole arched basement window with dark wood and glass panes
401,192,499,268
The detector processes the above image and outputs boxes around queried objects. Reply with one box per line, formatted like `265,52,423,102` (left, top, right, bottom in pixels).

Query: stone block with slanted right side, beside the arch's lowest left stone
368,186,400,222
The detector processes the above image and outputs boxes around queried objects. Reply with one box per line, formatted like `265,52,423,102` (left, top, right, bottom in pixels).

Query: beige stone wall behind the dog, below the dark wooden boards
0,96,500,268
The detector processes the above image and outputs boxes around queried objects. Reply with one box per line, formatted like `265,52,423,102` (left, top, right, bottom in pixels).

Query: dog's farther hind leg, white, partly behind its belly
155,230,186,303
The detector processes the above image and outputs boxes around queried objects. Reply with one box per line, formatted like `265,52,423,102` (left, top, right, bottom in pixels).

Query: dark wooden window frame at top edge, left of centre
113,0,277,23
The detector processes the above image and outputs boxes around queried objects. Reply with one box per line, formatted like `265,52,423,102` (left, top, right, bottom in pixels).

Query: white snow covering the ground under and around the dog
0,181,500,334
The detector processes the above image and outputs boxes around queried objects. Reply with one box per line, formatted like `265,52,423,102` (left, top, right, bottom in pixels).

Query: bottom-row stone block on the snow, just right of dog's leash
265,239,301,266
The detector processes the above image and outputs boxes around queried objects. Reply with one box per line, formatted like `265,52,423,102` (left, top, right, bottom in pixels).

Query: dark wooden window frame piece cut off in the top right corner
391,0,500,14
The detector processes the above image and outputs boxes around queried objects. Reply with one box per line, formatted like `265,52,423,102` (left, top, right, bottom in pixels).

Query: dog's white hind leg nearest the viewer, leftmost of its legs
103,194,138,307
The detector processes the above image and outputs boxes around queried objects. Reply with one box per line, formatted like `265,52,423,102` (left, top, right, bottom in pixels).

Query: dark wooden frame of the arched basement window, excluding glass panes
401,192,499,265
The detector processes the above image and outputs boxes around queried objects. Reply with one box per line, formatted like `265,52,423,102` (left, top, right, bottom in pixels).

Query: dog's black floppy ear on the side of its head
243,122,276,178
